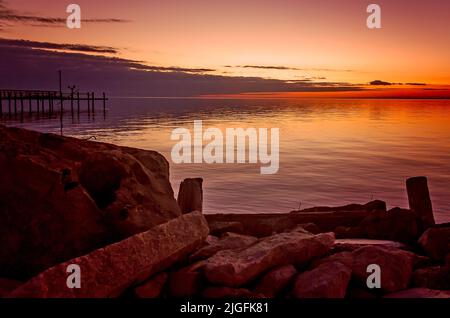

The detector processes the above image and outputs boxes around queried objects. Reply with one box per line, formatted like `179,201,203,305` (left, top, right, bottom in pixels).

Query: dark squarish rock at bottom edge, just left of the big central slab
168,268,202,298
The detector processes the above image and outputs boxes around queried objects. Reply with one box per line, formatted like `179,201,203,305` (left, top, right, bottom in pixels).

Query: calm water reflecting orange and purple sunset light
3,99,450,222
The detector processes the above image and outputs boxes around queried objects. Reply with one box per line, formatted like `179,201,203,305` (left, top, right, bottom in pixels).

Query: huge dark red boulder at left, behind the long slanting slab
0,126,181,279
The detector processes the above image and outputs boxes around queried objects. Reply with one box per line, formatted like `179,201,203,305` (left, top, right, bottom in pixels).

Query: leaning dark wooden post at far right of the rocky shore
406,177,435,231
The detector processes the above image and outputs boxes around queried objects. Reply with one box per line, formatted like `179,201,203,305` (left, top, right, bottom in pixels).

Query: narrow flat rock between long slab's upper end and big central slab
190,233,258,261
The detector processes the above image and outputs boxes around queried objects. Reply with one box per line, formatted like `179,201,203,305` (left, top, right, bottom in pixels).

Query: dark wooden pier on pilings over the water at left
0,89,108,118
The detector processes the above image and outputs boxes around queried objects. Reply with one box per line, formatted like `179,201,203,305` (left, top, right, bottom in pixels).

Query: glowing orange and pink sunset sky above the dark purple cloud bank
0,0,450,95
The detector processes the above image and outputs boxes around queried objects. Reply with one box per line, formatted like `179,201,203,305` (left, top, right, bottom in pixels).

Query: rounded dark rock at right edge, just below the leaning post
419,226,450,260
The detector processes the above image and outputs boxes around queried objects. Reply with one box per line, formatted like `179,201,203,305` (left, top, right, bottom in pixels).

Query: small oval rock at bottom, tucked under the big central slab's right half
254,265,297,298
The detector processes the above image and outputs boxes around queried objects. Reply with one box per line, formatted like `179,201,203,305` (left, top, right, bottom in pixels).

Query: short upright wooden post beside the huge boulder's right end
177,178,203,214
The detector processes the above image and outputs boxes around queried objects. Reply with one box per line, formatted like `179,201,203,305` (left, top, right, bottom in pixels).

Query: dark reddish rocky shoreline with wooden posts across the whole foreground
0,126,450,298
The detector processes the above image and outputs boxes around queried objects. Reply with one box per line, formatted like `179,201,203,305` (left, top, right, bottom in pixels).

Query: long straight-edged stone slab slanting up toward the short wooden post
10,212,209,298
